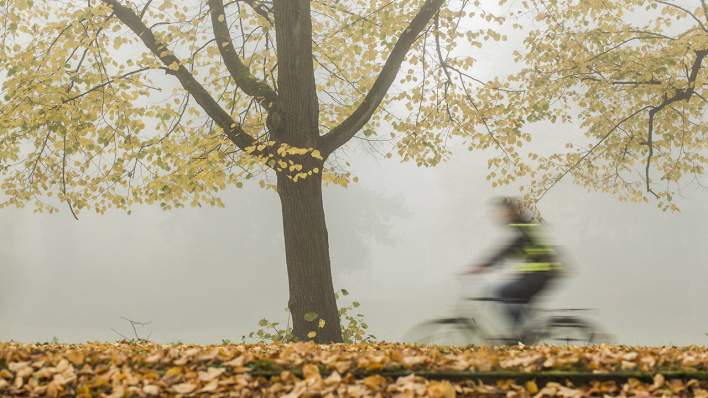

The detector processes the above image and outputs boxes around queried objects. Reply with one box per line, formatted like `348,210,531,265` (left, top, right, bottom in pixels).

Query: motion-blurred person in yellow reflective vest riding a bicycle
461,198,563,341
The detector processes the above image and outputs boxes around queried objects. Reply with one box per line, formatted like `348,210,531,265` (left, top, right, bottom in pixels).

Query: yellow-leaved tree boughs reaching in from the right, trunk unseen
498,0,708,215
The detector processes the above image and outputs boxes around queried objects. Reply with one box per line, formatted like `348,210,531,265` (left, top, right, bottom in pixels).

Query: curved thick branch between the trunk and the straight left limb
209,0,278,111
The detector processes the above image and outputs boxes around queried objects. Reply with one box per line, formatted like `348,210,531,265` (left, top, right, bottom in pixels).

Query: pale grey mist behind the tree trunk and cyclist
0,0,708,345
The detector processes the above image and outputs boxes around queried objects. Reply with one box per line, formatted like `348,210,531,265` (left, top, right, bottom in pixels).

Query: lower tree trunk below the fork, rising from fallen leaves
278,166,342,343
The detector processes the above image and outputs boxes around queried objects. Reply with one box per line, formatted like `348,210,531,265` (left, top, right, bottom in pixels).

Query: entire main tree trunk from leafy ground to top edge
269,0,342,343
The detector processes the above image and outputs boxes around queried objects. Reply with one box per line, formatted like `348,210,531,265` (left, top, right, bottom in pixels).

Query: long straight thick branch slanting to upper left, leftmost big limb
102,0,261,156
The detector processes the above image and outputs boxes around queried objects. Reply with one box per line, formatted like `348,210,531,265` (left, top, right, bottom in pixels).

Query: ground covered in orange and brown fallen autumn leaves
0,341,708,398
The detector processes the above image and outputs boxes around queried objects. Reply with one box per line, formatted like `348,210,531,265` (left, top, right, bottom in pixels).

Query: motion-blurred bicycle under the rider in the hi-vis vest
404,278,613,346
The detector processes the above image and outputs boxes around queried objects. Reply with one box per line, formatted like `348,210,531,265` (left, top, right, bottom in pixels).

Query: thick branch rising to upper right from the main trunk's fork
319,0,444,158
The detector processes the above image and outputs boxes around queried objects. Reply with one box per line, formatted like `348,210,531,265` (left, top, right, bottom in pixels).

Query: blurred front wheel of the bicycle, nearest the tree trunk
404,318,484,346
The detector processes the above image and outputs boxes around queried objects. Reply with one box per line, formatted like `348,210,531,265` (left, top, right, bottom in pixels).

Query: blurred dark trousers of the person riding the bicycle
499,271,555,329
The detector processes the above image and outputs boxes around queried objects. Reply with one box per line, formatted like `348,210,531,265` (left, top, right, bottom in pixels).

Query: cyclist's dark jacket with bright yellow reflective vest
481,223,563,272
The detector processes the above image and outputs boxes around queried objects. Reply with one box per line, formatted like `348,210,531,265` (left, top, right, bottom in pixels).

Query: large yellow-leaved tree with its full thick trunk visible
0,0,529,342
